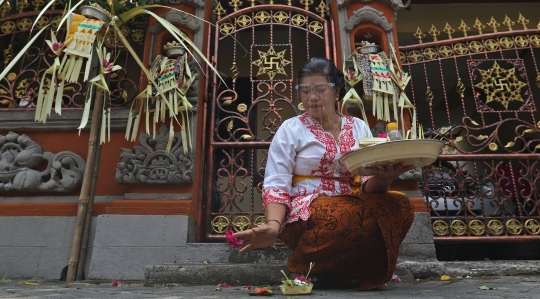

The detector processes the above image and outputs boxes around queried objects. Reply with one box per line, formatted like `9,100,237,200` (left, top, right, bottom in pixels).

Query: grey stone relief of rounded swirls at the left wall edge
0,132,86,192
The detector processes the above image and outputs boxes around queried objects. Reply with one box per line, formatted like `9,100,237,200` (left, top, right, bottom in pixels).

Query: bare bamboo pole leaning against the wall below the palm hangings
66,88,103,282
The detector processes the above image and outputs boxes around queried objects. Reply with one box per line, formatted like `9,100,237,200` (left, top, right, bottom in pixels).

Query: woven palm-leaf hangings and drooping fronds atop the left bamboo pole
0,0,223,151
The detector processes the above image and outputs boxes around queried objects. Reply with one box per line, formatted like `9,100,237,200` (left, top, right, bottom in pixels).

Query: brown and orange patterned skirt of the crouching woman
279,193,414,290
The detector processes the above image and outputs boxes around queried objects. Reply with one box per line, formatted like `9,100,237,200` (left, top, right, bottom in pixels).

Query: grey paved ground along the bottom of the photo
0,276,540,299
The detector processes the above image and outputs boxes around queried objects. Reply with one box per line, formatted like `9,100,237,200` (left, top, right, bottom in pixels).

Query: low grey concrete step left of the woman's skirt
144,264,287,286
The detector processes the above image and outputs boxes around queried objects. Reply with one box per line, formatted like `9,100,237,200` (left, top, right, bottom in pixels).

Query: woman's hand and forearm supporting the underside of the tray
364,162,416,193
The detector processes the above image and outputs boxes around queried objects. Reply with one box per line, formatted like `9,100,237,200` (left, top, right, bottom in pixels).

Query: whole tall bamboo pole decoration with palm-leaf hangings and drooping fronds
0,0,228,281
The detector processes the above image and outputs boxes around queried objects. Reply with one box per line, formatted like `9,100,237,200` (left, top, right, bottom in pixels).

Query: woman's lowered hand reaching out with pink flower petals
233,221,280,253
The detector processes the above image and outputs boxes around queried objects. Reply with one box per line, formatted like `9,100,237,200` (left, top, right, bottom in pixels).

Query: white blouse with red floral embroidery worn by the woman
262,113,372,229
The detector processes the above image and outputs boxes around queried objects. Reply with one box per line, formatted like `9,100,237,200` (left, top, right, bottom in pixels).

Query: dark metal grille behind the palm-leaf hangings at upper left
0,7,146,109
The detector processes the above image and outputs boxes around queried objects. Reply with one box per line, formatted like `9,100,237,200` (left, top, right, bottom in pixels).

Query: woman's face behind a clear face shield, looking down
297,74,338,124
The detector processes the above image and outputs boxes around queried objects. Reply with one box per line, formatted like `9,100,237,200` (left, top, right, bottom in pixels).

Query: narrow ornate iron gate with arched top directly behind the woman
199,1,331,241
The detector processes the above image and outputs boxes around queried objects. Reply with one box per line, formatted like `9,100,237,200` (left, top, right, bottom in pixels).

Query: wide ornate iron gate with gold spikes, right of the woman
400,15,540,242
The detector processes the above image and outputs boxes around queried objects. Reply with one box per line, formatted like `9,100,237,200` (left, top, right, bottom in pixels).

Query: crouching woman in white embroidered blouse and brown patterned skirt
234,58,414,290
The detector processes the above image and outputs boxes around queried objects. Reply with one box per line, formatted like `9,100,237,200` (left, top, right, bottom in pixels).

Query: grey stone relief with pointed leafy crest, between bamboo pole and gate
116,125,195,184
